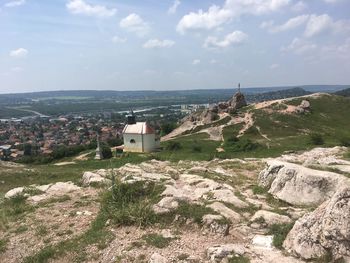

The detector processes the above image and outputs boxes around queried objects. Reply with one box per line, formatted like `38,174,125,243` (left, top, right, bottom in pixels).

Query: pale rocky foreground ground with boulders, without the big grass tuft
0,147,350,263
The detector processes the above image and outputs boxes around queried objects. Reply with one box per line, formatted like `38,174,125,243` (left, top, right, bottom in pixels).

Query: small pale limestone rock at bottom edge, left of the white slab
207,244,245,262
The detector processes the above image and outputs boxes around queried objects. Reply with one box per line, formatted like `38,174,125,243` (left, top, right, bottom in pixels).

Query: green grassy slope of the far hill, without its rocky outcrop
157,95,350,160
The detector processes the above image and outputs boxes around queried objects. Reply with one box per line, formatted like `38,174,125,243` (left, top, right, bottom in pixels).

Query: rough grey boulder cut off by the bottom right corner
283,187,350,262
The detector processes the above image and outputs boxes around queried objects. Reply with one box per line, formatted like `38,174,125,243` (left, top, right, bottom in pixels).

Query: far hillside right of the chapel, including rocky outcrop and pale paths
162,93,350,158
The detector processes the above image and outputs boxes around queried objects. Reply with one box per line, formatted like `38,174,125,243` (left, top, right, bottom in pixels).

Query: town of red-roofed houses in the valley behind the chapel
0,104,205,163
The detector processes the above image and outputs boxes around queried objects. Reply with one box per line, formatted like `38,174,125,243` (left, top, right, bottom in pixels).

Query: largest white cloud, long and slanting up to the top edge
176,0,290,34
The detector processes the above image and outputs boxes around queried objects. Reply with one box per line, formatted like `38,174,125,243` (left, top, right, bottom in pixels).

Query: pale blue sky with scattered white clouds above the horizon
0,0,350,93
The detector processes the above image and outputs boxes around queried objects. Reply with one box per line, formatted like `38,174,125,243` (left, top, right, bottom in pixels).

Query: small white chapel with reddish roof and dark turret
123,112,159,153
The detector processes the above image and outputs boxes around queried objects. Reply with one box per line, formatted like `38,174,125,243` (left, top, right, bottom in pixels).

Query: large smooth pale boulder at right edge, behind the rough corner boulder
259,160,350,205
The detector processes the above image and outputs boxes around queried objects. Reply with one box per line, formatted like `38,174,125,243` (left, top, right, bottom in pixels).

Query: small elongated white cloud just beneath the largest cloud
204,31,248,48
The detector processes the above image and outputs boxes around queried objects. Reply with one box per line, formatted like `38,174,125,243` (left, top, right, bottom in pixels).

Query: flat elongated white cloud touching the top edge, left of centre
66,0,117,18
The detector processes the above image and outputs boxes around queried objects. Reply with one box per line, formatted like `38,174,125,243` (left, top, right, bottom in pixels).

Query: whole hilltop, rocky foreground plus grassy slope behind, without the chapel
0,94,350,263
